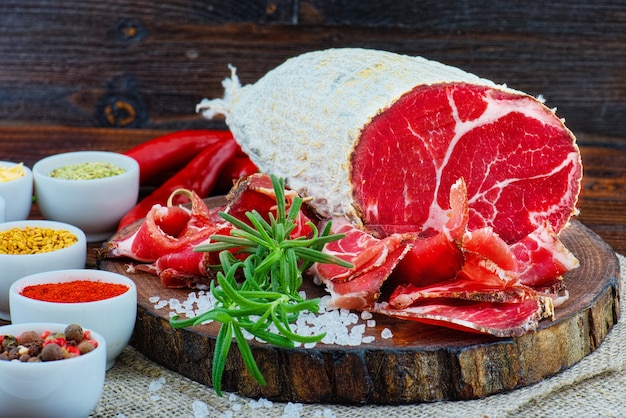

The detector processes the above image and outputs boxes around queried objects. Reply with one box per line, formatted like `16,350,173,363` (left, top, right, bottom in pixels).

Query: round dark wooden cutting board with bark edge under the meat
99,221,619,404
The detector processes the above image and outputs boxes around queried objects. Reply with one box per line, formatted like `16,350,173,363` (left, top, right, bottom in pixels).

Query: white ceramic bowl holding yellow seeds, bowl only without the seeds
0,220,87,320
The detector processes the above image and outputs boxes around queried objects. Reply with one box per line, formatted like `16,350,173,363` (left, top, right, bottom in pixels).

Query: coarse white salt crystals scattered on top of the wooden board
150,290,392,348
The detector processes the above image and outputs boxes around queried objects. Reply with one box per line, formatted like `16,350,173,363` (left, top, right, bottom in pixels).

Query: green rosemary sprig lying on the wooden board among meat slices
170,176,352,395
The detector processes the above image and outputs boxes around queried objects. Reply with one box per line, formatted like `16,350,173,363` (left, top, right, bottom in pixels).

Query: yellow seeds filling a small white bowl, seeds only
0,226,78,254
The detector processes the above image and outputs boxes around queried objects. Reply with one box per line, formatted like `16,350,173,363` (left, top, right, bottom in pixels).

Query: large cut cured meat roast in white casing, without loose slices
198,48,582,244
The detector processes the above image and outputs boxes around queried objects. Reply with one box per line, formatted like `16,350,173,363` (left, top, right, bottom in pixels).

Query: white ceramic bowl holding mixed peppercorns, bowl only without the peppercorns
0,323,106,418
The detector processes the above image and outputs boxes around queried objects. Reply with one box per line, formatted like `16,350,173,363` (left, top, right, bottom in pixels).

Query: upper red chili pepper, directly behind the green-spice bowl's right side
124,129,233,184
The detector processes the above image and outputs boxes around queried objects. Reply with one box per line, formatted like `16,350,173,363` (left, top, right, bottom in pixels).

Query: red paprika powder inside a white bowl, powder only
20,280,129,303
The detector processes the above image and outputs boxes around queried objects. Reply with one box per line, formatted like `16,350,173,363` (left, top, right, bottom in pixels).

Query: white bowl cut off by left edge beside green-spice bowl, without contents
0,161,33,222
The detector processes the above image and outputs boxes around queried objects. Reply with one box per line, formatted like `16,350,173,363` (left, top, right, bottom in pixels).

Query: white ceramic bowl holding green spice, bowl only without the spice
33,151,139,242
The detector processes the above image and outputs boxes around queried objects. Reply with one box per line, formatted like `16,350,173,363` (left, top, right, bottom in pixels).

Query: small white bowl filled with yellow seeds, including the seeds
0,220,87,320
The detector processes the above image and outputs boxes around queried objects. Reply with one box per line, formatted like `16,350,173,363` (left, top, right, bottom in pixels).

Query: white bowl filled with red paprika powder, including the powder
9,269,137,369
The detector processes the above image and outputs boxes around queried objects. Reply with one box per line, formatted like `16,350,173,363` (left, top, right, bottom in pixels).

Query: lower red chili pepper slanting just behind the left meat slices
118,139,239,230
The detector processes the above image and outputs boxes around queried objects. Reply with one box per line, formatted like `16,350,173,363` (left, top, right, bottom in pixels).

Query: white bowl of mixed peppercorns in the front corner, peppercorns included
0,322,106,418
